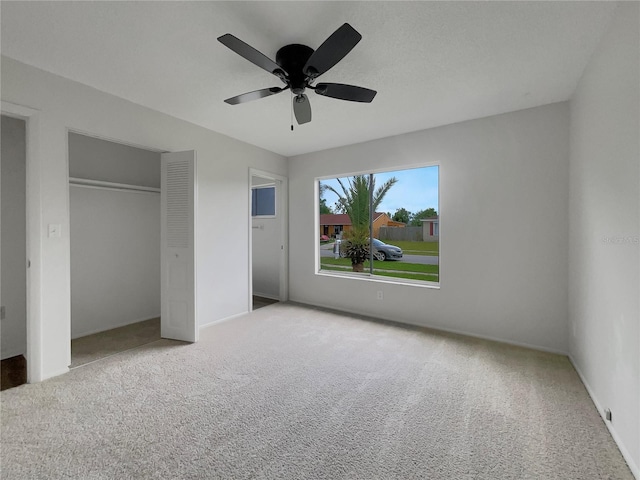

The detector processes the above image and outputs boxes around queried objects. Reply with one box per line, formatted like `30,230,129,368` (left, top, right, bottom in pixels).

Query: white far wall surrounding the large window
289,103,569,352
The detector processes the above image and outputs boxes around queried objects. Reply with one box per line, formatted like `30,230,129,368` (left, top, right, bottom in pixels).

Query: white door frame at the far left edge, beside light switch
0,101,42,383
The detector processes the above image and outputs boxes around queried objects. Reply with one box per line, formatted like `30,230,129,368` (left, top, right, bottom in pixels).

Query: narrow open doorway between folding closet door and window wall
249,169,288,311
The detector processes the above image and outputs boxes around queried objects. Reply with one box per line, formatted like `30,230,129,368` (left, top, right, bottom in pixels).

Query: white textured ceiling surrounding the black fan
0,1,616,156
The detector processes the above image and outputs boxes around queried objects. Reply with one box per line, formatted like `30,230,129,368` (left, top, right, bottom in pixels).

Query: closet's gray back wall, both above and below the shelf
69,133,160,338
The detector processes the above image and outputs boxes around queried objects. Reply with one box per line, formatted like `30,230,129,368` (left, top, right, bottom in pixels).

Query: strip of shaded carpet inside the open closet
70,317,160,368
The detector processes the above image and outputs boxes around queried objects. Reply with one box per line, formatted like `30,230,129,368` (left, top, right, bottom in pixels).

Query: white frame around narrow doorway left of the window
247,168,289,312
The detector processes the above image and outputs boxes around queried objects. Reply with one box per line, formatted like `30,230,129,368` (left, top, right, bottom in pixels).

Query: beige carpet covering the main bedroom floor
0,303,632,480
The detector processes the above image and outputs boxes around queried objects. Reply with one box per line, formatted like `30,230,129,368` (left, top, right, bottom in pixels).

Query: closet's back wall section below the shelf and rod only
69,187,160,338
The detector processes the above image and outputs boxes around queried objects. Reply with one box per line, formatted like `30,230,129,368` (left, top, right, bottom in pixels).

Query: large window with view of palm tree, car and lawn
317,166,440,284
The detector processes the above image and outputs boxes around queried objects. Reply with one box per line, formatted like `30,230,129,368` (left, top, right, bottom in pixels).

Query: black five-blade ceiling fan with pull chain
218,23,377,125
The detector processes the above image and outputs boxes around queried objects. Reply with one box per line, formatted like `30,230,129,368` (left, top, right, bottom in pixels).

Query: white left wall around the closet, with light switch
1,57,287,380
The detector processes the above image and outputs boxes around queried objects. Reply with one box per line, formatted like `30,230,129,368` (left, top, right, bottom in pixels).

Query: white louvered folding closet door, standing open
160,150,198,342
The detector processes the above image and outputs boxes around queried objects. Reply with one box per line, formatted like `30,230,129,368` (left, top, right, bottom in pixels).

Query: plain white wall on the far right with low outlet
569,2,640,478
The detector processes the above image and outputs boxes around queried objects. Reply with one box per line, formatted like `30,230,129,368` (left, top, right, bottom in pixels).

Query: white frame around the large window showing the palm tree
313,161,442,290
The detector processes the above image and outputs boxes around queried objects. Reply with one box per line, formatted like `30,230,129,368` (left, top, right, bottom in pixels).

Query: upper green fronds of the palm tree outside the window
323,175,398,228
